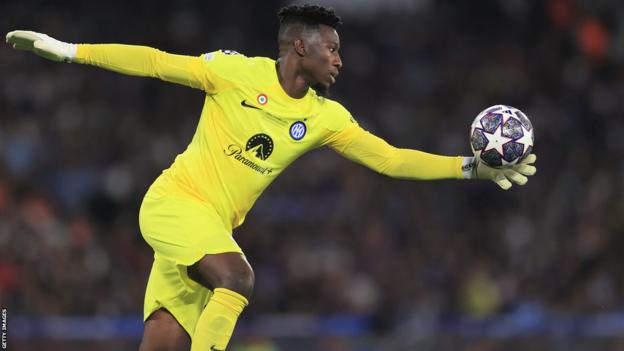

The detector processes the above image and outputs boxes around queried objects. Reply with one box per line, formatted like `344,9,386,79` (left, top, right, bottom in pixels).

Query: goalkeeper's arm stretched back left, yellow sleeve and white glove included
6,30,213,91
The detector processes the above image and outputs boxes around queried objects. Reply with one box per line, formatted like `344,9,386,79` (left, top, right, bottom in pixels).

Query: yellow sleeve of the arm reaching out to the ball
329,125,463,180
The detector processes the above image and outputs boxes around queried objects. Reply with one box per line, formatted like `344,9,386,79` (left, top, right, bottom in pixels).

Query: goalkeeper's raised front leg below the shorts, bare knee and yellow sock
188,252,254,351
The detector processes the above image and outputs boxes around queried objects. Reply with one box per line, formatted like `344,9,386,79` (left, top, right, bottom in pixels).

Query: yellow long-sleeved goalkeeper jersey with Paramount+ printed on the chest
75,44,462,229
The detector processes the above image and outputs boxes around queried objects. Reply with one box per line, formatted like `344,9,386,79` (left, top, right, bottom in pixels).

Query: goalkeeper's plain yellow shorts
139,191,243,337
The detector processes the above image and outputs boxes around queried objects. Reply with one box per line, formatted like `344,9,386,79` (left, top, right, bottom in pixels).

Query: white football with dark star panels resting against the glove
470,105,533,167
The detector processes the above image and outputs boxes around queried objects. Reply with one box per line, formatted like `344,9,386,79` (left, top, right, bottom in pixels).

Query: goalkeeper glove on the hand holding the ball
462,154,537,190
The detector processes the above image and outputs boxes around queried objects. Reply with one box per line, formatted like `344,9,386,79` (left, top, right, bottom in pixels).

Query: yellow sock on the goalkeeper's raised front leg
191,288,248,351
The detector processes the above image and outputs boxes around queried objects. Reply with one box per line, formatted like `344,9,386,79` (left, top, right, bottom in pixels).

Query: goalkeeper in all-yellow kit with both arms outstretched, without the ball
6,5,535,351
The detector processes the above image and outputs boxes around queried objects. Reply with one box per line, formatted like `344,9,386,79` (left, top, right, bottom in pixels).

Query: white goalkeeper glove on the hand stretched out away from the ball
6,30,76,63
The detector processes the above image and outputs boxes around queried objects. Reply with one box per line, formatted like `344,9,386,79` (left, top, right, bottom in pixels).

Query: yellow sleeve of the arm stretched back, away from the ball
74,44,215,92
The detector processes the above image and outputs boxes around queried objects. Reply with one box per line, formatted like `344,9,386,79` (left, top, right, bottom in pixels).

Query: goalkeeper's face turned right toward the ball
302,25,342,95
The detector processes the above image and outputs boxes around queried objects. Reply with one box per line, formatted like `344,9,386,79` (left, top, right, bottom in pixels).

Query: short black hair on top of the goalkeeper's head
277,4,342,29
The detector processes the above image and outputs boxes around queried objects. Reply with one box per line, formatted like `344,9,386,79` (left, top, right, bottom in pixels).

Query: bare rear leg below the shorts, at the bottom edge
139,309,191,351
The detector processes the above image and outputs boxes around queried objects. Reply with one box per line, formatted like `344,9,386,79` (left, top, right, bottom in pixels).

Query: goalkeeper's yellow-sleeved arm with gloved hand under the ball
333,126,536,190
